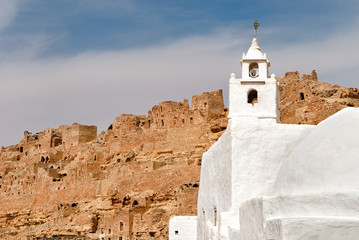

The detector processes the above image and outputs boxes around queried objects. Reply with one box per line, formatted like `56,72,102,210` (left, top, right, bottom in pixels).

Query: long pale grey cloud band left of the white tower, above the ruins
0,26,244,145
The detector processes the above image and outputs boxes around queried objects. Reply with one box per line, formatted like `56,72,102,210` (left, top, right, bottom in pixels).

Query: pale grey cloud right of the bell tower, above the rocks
270,15,359,87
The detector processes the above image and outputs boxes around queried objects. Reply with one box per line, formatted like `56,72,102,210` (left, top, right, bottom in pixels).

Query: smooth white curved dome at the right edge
275,108,359,195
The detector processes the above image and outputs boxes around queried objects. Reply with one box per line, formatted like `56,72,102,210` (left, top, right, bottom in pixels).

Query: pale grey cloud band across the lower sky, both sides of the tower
0,1,359,145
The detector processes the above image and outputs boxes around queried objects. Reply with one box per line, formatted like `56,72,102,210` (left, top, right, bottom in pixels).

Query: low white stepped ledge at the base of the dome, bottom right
239,193,359,240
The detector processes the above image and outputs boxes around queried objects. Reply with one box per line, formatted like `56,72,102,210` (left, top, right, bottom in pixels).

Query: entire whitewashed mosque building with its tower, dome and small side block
169,21,359,240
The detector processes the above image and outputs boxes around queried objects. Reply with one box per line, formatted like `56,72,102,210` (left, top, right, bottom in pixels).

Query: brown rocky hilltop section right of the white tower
277,70,359,124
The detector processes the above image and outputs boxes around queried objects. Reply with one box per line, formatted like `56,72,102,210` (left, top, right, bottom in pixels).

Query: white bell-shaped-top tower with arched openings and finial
229,20,279,122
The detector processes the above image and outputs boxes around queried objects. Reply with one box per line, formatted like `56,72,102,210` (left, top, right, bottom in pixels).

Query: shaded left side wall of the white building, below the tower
197,127,232,239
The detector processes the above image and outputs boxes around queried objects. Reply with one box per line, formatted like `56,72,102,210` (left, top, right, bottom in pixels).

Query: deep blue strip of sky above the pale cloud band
3,0,358,54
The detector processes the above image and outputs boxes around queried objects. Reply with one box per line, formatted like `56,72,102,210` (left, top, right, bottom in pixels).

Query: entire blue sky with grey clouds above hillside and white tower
0,0,359,146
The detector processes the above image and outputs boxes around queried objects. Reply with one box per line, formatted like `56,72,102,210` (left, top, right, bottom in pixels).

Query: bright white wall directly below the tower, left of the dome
230,117,314,209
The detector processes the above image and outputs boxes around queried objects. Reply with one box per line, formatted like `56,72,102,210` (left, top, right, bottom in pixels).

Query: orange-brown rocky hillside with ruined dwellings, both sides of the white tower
0,72,359,240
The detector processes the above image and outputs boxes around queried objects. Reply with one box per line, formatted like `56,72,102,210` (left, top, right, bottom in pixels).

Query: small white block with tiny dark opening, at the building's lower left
169,216,197,240
